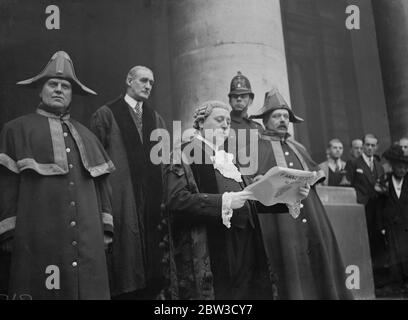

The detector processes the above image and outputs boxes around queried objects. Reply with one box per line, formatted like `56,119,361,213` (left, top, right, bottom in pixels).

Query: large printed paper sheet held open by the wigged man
245,167,321,218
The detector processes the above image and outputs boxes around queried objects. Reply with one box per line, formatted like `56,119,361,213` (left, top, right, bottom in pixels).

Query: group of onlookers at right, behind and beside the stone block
320,134,408,292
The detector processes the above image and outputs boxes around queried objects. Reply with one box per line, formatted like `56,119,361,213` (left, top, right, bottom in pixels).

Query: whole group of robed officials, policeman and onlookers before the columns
0,51,408,299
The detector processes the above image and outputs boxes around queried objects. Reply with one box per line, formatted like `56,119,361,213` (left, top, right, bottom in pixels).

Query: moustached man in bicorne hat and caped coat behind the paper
247,89,352,300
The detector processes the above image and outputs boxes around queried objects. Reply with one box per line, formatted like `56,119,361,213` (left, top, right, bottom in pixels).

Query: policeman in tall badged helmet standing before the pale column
228,71,263,159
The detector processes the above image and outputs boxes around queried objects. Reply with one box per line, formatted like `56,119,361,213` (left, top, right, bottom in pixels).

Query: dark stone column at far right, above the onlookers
372,0,408,141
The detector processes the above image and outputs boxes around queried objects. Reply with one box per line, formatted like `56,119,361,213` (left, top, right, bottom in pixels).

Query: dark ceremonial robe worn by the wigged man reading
165,139,273,299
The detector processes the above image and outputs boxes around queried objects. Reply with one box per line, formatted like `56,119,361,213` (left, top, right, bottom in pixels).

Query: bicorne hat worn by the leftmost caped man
17,51,96,95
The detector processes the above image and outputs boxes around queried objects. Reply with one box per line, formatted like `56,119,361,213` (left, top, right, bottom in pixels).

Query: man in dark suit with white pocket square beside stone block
346,134,384,280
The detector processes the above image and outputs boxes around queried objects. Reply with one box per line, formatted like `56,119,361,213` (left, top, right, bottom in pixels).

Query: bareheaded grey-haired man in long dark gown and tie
91,66,165,299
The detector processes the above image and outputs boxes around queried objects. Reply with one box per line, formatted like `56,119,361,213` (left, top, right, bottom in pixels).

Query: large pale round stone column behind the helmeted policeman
168,0,290,128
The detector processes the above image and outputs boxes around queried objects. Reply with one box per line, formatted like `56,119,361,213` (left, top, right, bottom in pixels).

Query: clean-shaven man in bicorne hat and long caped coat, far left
0,51,114,299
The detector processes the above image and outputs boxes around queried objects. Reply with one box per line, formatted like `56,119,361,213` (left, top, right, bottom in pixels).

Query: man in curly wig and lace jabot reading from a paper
164,101,274,300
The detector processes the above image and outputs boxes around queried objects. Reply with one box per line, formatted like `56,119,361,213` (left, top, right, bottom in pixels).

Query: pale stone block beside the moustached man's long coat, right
316,186,375,299
